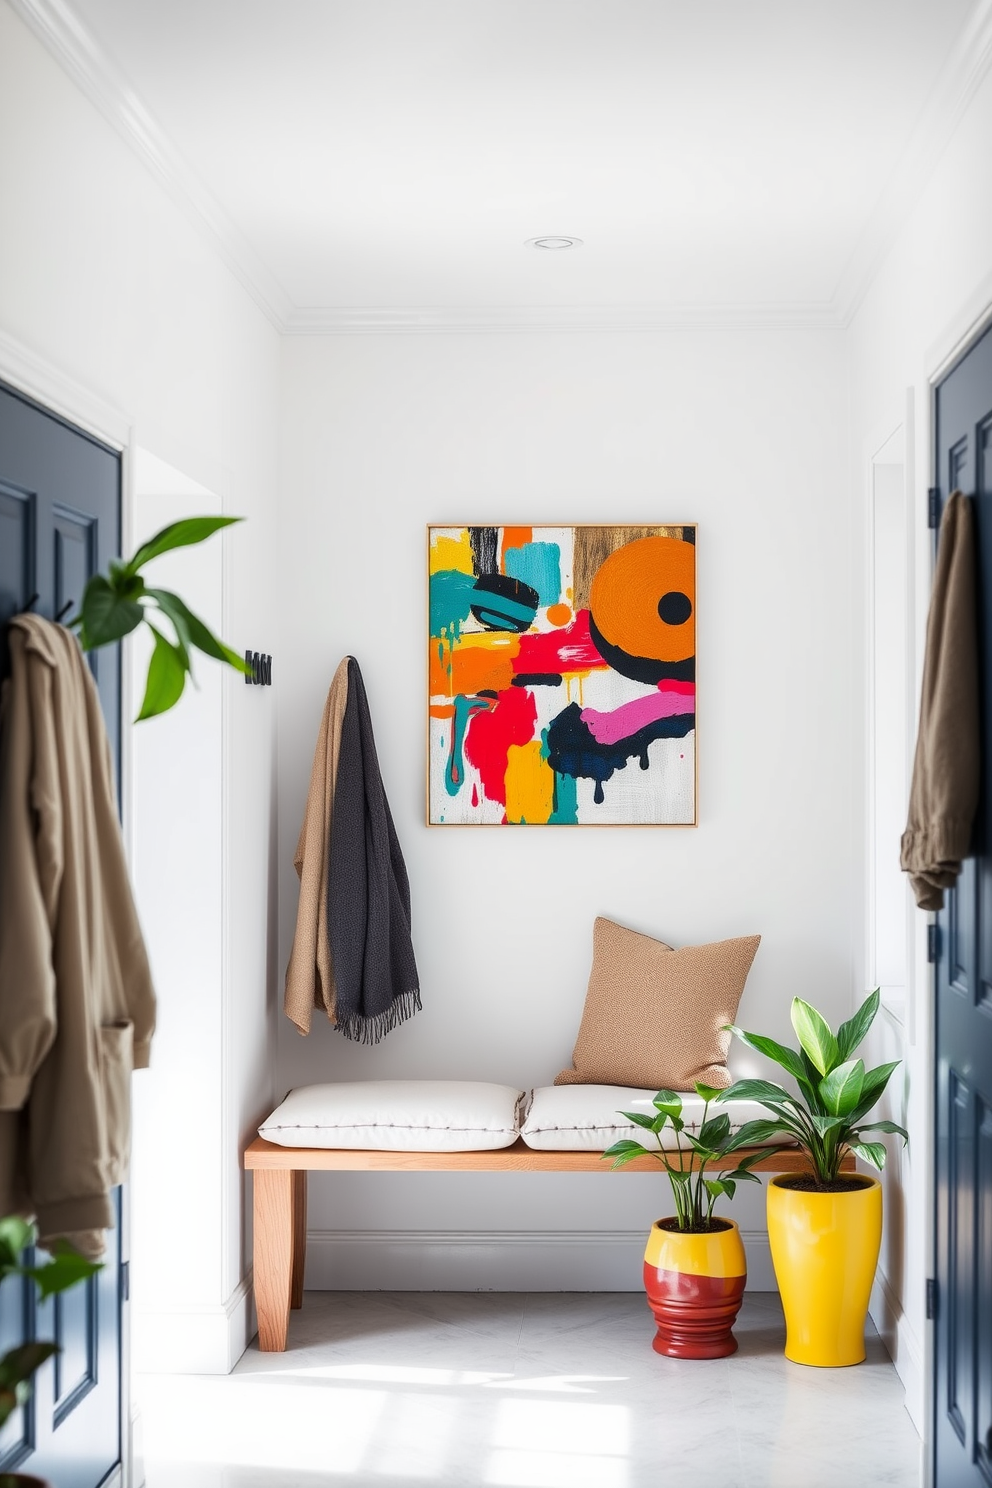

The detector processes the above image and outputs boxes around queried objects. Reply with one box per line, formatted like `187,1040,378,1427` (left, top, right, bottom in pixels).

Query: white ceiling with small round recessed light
10,0,992,330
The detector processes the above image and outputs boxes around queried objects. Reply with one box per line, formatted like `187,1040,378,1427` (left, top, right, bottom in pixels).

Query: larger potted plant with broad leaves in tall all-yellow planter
717,987,909,1367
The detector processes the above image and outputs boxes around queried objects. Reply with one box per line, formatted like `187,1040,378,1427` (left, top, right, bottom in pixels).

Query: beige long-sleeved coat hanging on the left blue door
0,615,155,1254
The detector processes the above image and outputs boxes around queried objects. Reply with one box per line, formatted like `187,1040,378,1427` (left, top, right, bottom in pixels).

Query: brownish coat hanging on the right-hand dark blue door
900,491,980,909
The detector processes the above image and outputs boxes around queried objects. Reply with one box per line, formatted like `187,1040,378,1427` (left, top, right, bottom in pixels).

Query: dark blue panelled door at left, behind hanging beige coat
0,387,122,1488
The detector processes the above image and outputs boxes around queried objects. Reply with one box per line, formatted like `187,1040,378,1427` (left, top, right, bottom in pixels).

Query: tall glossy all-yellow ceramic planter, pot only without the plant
767,1176,882,1367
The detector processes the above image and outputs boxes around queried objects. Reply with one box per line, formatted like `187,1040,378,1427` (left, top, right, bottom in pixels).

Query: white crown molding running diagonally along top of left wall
7,0,293,330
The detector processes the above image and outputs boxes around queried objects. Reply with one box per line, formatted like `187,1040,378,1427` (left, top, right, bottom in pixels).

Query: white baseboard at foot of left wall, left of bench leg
131,1274,256,1375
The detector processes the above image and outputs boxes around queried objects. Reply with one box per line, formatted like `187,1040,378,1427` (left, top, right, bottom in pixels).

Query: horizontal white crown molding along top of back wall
283,302,843,336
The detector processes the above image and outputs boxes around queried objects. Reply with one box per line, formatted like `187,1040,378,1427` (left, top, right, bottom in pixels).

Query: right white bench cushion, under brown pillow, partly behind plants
521,1085,782,1152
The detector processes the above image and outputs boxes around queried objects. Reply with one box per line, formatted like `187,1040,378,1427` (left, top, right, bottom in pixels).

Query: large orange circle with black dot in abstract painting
589,537,696,661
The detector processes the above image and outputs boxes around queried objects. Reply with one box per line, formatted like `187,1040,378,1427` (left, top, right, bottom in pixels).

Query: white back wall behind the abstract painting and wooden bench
277,332,860,1287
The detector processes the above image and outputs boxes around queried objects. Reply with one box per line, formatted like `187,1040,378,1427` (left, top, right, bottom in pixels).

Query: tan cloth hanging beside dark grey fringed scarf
283,656,348,1034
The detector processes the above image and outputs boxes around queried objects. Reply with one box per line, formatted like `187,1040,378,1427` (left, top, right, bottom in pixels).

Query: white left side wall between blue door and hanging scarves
0,4,278,1369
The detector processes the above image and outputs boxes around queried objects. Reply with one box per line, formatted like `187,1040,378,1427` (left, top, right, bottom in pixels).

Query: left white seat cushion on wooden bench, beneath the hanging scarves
259,1080,524,1152
